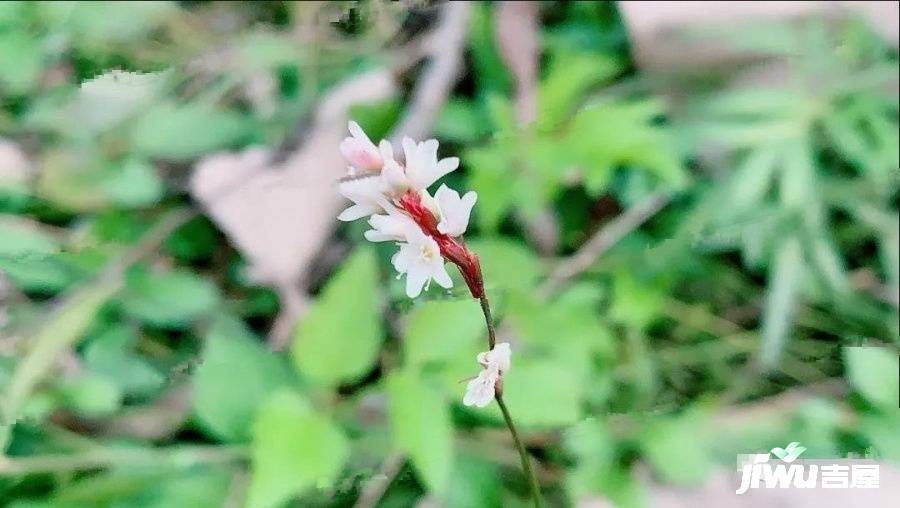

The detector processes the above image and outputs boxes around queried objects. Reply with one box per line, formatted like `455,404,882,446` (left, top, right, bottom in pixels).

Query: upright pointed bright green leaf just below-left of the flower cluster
291,248,382,386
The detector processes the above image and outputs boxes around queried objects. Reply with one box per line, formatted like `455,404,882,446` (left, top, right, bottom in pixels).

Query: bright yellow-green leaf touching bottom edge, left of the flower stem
247,391,350,508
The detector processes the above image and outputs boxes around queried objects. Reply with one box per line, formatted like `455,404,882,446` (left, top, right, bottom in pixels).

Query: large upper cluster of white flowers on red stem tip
338,122,484,298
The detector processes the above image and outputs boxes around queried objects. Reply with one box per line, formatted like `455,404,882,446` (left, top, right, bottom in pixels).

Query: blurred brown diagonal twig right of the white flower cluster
538,192,670,298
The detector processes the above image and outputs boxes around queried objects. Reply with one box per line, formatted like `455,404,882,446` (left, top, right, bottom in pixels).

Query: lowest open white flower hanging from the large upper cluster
391,224,453,298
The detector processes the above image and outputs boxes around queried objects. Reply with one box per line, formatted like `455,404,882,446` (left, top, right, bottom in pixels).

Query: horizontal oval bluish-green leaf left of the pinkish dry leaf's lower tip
121,270,219,328
